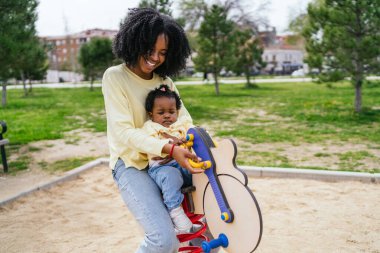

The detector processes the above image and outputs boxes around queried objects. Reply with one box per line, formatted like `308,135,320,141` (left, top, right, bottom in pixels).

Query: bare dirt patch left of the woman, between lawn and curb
0,129,109,200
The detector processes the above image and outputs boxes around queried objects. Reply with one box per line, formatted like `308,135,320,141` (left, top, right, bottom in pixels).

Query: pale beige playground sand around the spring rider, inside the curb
0,166,380,253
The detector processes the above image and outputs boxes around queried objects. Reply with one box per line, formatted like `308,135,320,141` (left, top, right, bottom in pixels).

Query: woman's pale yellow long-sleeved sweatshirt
102,64,192,169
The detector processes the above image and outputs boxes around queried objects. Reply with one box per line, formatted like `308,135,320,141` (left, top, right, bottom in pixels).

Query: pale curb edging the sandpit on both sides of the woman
0,158,380,207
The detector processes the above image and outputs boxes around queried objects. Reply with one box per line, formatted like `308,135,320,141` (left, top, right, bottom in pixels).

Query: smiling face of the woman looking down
132,34,169,80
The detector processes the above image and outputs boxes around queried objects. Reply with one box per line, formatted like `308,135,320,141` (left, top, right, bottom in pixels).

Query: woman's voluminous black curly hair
112,8,191,77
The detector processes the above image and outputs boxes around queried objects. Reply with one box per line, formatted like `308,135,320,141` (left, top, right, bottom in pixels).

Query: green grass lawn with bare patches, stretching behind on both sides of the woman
0,83,380,172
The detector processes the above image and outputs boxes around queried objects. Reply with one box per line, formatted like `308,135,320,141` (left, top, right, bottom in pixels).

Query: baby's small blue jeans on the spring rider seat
148,160,192,211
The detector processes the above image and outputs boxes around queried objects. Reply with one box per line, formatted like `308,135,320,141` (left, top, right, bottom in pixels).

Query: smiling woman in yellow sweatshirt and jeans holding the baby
102,8,202,253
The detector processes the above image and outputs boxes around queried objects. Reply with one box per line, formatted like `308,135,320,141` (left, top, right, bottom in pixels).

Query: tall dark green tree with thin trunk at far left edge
0,0,38,107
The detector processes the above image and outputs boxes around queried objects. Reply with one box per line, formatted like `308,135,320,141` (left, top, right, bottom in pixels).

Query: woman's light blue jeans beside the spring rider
112,159,179,253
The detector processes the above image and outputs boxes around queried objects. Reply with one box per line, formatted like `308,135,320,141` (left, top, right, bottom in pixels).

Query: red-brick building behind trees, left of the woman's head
40,28,117,72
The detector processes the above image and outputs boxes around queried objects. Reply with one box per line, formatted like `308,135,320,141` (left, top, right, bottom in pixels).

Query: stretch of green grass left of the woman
0,88,106,144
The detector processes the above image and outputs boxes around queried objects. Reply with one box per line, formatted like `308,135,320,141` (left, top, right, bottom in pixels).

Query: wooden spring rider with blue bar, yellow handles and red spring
178,127,263,253
